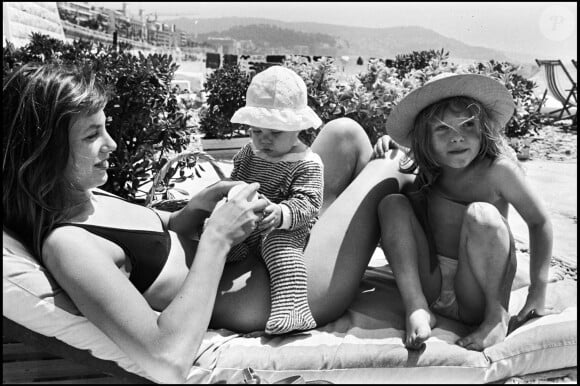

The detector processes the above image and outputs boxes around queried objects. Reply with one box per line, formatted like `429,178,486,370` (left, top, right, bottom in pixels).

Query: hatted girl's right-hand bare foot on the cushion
456,308,510,351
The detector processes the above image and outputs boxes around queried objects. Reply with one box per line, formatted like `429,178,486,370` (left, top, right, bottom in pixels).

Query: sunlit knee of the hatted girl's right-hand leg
463,202,507,239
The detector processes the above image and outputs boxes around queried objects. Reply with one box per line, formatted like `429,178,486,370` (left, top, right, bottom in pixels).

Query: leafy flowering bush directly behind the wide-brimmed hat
285,50,542,144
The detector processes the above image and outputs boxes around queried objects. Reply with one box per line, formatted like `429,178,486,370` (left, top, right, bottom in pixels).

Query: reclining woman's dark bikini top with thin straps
55,191,171,293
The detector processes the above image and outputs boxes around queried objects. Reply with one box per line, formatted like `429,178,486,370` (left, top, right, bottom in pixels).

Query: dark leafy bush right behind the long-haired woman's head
3,34,189,201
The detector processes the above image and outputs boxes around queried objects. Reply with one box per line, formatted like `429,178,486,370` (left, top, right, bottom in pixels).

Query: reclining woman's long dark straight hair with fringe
2,64,107,259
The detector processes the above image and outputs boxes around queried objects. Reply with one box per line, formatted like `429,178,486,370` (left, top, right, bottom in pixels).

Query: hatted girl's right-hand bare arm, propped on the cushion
493,160,553,318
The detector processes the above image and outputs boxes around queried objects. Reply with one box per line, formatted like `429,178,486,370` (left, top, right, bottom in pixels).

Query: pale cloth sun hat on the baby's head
231,66,322,131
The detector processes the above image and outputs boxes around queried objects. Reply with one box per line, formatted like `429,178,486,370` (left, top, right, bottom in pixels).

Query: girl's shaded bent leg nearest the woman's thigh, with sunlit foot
379,194,441,349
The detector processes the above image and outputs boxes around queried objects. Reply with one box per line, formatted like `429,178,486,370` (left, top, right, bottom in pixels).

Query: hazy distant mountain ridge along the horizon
165,17,528,61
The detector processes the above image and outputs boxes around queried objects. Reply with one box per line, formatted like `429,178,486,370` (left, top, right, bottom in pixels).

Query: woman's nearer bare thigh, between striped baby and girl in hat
304,151,413,325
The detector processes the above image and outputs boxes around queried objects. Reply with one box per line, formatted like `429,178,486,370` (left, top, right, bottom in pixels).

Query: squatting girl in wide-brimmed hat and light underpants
379,74,552,350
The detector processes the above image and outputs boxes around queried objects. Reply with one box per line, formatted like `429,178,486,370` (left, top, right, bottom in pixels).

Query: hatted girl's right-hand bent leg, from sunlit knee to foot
455,202,516,351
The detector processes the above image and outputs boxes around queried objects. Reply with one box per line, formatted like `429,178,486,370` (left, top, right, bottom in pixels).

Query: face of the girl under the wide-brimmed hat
428,109,482,169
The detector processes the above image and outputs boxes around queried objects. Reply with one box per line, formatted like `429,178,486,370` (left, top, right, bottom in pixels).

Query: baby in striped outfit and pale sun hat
228,66,324,334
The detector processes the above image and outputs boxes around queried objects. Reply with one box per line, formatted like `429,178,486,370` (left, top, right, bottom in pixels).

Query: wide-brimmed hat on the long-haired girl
386,73,516,147
